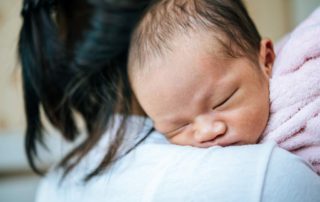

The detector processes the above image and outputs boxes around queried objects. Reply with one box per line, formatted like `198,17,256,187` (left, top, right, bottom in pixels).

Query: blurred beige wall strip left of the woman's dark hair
0,0,24,131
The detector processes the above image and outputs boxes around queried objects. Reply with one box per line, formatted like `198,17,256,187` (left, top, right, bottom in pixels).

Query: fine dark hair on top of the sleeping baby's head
129,0,261,66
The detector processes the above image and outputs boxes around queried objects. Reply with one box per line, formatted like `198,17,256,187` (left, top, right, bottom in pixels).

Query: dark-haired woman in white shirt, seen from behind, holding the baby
19,0,320,201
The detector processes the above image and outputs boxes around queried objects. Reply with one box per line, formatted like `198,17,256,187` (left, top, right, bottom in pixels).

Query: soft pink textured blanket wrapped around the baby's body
262,8,320,174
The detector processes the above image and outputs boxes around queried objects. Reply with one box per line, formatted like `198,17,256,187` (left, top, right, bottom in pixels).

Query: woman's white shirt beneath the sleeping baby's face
36,118,320,202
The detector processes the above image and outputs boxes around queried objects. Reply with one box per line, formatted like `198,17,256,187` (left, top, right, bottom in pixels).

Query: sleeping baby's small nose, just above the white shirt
194,117,227,143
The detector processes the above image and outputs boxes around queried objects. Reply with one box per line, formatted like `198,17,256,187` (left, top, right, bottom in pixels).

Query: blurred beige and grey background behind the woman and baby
0,0,320,202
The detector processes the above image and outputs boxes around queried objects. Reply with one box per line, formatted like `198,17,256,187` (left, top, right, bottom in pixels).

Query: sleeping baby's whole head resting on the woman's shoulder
128,0,274,147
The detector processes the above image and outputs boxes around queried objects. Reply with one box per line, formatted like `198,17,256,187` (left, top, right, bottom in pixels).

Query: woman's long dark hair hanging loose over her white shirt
19,0,151,180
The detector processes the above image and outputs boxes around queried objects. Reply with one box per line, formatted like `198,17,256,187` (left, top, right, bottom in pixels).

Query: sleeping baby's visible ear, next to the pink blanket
259,39,275,77
